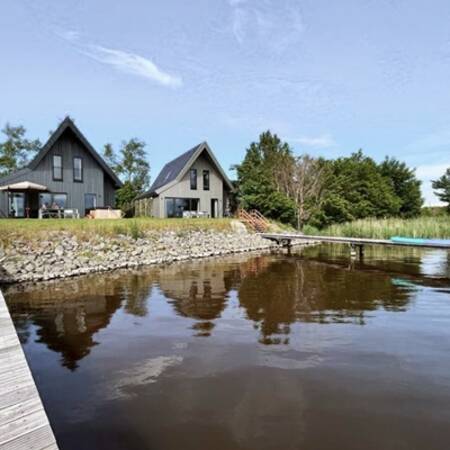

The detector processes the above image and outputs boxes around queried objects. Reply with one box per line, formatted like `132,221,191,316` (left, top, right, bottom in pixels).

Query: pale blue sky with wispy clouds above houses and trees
0,0,450,204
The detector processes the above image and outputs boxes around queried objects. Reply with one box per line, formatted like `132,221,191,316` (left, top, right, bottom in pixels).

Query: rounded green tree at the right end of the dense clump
379,157,423,217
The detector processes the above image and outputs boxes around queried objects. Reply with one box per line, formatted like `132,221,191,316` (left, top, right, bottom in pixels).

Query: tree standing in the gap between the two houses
103,138,150,208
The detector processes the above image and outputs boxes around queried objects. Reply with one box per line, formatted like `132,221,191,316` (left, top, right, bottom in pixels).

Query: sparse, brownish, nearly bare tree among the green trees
275,154,325,230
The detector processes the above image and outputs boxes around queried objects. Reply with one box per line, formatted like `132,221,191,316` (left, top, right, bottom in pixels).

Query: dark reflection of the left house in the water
9,277,126,370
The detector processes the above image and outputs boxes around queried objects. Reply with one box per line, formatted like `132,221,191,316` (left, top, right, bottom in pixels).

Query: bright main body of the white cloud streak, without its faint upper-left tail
82,45,183,87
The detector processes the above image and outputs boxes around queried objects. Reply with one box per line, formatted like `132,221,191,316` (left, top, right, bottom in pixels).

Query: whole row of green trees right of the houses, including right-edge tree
235,131,450,229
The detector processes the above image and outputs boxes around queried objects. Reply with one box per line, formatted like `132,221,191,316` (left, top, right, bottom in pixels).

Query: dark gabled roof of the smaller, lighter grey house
138,142,233,198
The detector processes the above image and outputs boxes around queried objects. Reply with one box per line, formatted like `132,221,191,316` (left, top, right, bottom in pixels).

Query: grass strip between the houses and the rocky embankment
0,217,231,242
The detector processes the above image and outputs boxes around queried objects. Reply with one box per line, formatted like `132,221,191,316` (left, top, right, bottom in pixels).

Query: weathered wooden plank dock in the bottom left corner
0,291,58,450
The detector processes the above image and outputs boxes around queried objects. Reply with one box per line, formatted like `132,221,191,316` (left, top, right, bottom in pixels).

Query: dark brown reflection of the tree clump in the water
239,255,409,344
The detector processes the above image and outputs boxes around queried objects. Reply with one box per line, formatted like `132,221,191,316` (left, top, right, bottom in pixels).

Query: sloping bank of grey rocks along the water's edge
0,230,306,284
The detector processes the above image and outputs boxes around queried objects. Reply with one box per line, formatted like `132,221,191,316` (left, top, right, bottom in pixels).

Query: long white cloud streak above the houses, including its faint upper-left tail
56,30,183,88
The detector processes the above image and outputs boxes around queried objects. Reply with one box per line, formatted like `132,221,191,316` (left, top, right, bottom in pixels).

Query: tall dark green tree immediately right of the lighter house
235,131,295,223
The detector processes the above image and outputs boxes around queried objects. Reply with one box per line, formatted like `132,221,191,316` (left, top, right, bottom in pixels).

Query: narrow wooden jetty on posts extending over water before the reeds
259,233,450,257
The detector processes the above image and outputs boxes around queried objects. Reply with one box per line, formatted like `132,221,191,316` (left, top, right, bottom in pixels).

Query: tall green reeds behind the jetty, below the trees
305,215,450,239
